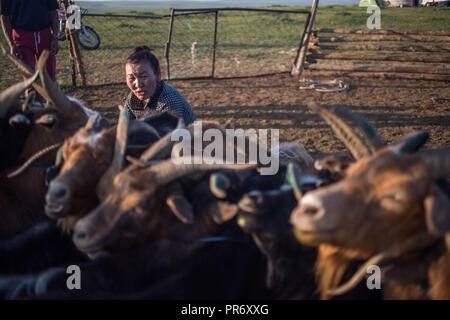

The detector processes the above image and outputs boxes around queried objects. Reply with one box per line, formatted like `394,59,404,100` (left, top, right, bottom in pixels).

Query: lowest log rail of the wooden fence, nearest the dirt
302,71,450,81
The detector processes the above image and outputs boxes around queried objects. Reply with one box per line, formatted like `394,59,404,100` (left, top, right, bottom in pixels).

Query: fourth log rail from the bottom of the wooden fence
310,43,450,53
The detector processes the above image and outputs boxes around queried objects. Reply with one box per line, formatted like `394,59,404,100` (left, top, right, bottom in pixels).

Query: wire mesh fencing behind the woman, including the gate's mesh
0,9,307,90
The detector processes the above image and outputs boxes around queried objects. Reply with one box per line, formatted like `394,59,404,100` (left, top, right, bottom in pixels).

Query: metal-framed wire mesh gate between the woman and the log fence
165,8,310,80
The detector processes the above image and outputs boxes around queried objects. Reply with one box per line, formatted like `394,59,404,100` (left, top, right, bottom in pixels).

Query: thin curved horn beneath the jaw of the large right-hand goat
325,231,439,296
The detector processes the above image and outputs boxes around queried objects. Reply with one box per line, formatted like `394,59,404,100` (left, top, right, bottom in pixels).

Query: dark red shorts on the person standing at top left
13,28,56,80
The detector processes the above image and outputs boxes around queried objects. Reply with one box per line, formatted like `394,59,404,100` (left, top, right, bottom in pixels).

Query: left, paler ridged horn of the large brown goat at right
308,102,370,160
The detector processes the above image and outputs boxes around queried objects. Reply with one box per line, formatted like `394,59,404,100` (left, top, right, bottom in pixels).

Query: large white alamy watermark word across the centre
171,121,280,175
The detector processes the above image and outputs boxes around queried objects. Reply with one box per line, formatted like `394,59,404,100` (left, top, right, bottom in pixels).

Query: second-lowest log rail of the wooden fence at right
305,63,450,75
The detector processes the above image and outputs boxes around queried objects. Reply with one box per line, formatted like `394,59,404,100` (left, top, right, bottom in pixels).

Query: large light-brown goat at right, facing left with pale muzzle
291,139,450,299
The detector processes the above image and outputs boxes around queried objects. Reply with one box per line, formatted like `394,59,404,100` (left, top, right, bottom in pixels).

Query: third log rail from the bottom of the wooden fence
308,53,450,63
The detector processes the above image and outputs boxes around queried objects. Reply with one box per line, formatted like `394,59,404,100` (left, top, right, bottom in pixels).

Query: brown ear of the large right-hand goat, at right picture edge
424,185,450,235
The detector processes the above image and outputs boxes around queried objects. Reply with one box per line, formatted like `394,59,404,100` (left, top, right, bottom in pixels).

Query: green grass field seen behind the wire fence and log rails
0,5,450,90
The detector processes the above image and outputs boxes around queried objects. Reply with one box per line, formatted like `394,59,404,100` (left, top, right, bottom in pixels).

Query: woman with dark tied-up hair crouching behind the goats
124,46,196,125
